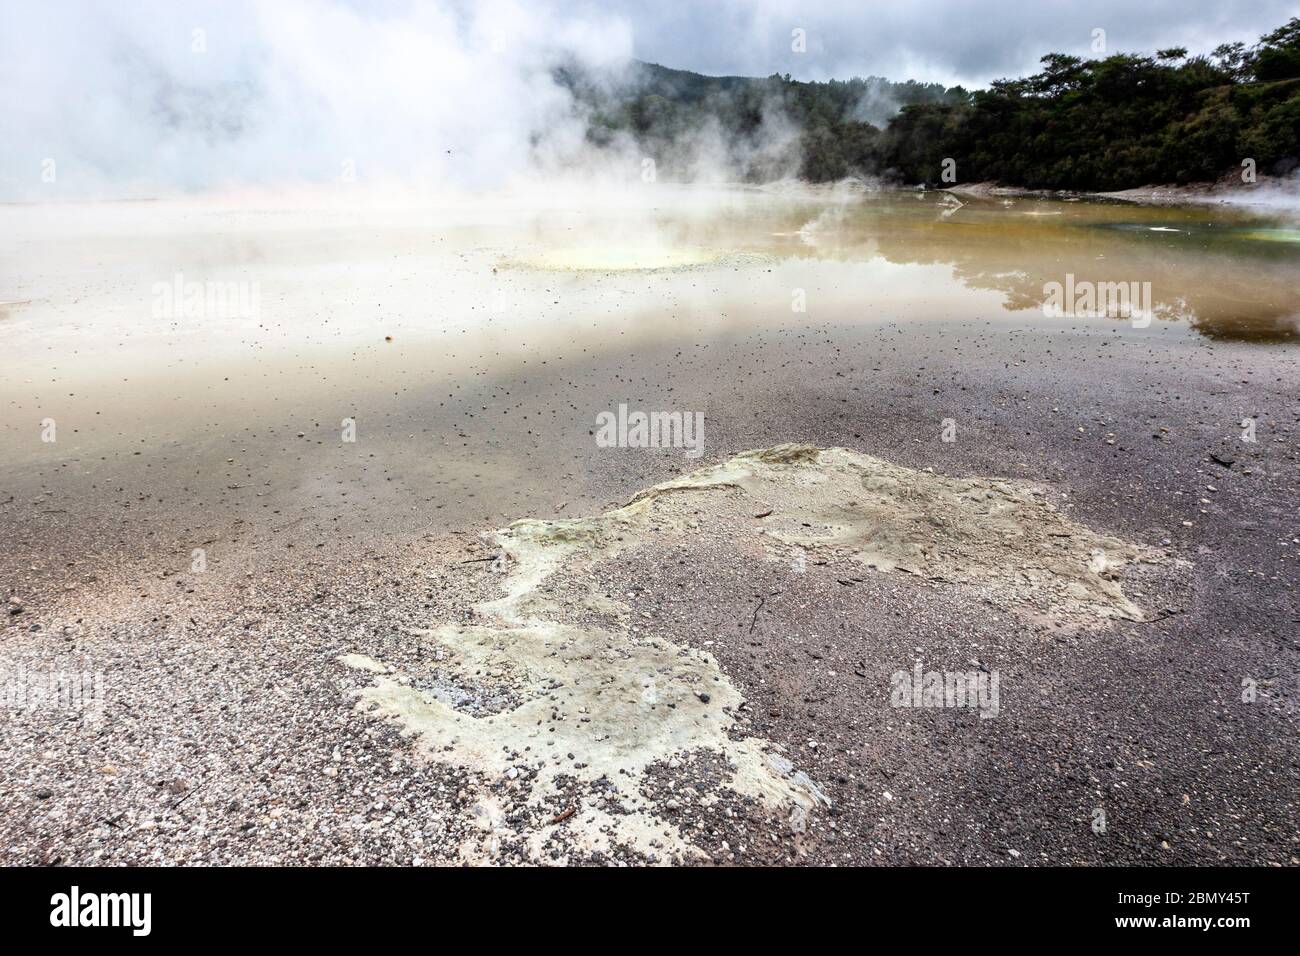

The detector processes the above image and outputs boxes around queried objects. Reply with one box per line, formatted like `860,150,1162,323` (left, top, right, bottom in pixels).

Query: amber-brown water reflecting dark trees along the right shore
847,200,1300,342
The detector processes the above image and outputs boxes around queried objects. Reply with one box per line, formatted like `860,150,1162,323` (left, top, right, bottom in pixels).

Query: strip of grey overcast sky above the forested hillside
595,0,1300,86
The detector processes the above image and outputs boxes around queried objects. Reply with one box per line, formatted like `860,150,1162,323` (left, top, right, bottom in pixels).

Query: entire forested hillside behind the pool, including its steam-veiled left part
558,17,1300,190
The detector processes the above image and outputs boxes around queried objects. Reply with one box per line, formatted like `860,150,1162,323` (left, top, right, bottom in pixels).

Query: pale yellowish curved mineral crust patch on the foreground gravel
341,445,1156,861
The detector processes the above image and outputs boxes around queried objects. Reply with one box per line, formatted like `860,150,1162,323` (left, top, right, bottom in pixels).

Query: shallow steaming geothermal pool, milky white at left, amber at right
0,180,1300,561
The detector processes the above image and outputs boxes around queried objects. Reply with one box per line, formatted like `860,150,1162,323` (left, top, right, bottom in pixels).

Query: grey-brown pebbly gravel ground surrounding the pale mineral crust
0,321,1300,865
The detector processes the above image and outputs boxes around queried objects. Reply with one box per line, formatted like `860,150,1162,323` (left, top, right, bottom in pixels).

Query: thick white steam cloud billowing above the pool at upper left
0,0,632,199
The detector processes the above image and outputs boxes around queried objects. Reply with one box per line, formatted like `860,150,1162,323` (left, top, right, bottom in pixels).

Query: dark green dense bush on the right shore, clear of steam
879,18,1300,190
